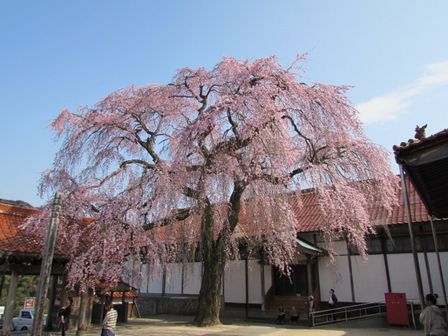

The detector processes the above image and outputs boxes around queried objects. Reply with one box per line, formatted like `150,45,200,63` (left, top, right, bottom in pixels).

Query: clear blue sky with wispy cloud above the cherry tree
0,0,448,205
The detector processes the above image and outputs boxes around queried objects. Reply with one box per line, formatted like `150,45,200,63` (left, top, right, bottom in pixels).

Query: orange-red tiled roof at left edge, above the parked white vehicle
0,203,64,256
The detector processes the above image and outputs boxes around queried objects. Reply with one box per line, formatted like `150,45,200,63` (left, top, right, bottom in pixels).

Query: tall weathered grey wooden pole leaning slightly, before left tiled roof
32,192,62,336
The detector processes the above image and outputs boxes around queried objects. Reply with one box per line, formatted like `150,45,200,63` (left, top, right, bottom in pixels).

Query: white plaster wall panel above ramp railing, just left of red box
351,254,388,302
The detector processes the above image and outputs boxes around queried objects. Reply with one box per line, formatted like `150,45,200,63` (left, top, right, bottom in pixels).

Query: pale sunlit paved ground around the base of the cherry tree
41,316,423,336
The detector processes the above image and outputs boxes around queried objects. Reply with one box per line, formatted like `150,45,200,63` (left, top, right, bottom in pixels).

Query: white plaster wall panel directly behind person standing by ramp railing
318,256,352,302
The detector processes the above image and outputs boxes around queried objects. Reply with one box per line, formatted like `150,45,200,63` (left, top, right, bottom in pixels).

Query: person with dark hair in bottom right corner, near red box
420,294,448,336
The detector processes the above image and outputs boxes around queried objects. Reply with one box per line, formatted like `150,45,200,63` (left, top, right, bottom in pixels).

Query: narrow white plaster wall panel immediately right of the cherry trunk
224,260,246,303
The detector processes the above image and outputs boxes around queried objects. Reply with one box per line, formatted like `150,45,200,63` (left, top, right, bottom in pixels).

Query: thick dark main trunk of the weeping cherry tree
195,202,226,326
